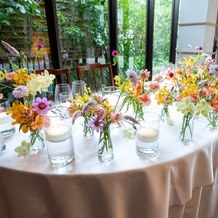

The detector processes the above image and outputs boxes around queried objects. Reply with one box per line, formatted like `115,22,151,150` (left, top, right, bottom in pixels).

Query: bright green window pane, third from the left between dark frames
117,0,146,77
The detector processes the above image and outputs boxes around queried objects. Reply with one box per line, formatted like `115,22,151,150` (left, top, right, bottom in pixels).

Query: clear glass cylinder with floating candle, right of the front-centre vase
136,112,160,158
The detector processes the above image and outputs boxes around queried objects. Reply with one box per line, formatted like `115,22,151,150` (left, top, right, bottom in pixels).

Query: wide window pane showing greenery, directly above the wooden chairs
56,0,109,80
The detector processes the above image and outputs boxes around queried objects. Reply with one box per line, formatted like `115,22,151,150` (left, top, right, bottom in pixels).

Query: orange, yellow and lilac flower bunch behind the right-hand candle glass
114,69,163,119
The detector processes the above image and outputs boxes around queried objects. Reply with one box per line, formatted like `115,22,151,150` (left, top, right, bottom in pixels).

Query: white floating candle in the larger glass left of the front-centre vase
45,125,72,142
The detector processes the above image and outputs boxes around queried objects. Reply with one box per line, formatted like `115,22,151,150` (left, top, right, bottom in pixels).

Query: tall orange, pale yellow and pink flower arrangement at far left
0,41,55,156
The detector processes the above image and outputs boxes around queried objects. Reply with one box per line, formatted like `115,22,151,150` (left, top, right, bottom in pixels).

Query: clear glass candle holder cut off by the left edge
0,98,15,138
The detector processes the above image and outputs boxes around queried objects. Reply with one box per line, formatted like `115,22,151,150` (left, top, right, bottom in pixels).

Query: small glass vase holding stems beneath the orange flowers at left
30,129,45,151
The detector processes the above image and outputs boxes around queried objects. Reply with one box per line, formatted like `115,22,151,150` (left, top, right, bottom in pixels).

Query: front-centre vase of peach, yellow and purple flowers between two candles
69,87,138,162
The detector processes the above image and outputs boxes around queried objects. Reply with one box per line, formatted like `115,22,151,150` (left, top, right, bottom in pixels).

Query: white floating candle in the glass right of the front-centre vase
136,127,159,142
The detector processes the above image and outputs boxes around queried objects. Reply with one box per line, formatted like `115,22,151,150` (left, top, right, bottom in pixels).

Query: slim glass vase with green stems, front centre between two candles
98,125,114,162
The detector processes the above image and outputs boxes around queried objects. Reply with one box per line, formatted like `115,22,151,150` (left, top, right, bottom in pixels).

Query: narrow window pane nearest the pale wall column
153,0,173,74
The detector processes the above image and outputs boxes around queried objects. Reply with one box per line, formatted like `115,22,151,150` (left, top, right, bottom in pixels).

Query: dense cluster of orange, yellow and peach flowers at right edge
158,47,218,141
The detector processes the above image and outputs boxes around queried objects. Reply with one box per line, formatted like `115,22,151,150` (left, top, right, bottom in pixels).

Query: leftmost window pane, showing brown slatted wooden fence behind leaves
0,0,51,96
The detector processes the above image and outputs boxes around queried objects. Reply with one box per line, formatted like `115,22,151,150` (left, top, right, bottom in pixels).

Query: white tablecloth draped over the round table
0,103,218,218
